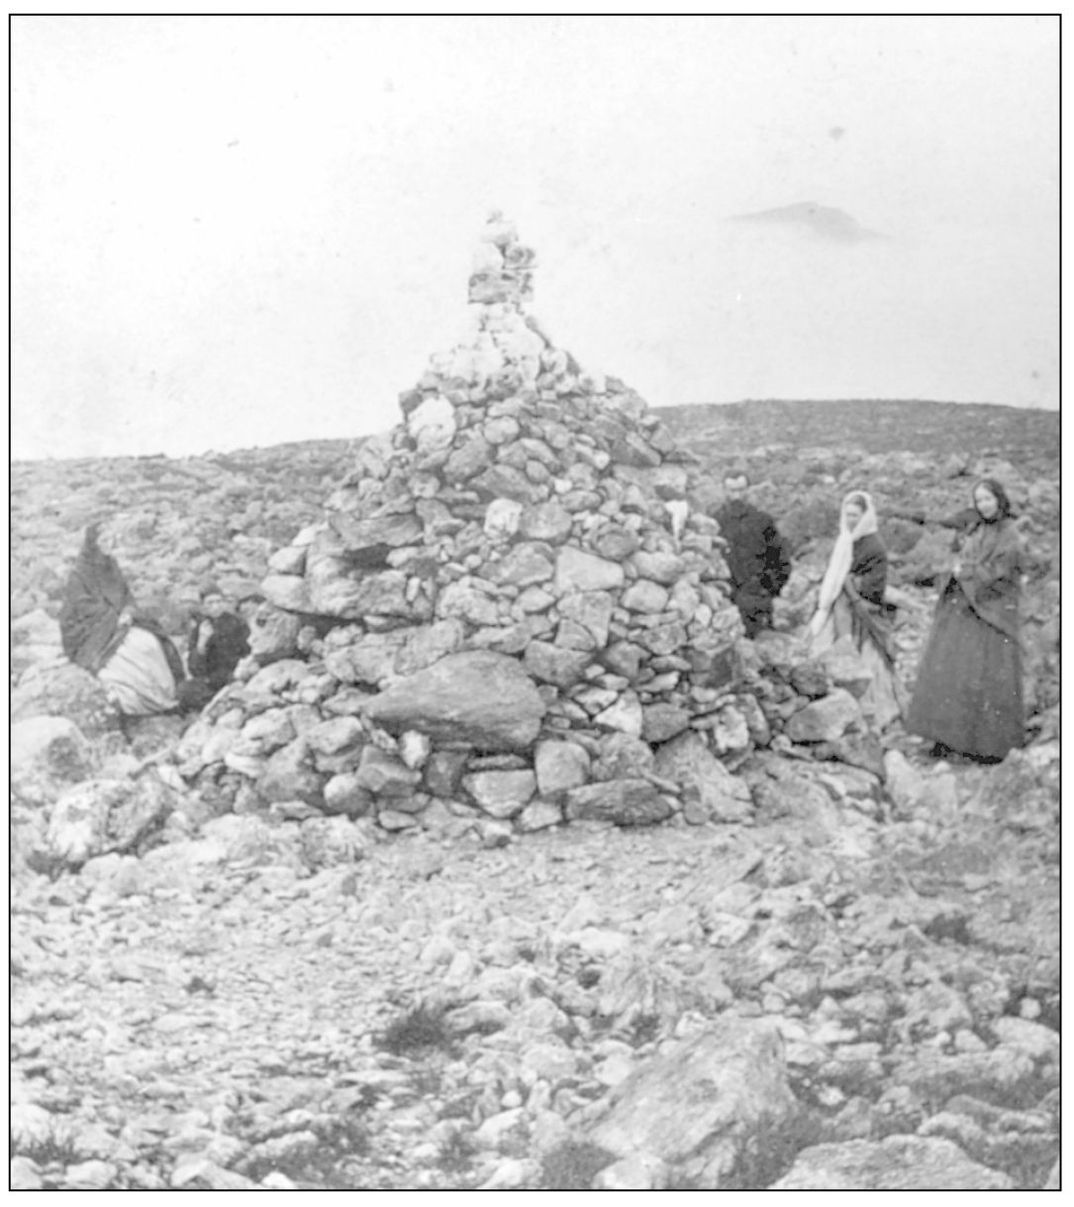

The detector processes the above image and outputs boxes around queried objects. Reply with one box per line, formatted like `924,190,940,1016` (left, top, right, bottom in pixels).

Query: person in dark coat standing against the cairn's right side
714,470,790,637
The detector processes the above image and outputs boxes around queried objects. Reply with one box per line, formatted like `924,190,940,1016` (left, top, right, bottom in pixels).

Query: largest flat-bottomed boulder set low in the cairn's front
362,649,545,751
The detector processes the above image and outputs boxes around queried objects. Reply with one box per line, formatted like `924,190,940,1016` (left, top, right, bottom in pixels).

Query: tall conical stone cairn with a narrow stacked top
179,214,767,833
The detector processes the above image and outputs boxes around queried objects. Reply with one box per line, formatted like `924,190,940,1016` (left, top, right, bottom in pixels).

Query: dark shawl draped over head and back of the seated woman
59,525,133,675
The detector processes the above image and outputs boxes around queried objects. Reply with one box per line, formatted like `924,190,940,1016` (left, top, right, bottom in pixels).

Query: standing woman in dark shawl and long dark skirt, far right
906,478,1026,763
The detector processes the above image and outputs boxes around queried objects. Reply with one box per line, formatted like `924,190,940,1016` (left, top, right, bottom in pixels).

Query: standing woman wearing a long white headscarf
809,490,904,730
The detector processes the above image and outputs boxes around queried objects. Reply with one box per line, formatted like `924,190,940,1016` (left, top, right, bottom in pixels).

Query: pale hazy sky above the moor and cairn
11,16,1060,460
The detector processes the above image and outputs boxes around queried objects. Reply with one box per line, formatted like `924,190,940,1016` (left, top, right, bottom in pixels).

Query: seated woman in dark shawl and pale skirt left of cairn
59,524,183,717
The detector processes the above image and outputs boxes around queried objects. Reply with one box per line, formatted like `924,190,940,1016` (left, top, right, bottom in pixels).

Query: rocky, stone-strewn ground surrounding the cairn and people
11,403,1060,1189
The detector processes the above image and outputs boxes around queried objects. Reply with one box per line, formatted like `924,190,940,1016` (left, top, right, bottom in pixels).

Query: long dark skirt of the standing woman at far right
906,583,1026,759
